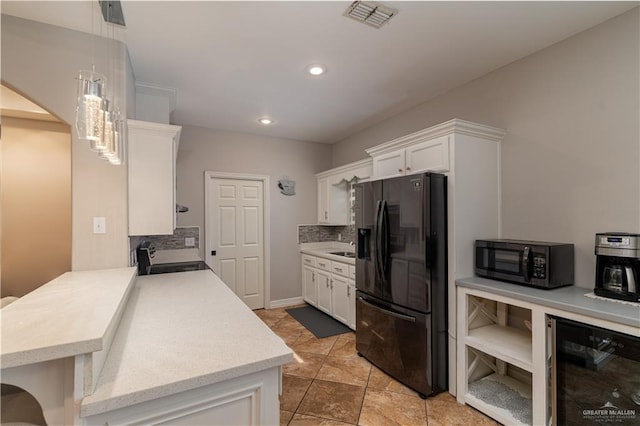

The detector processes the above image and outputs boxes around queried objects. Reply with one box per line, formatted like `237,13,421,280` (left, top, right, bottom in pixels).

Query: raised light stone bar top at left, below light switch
0,268,136,369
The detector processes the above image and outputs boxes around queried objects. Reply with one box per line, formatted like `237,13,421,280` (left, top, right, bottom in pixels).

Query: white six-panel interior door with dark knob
206,177,265,309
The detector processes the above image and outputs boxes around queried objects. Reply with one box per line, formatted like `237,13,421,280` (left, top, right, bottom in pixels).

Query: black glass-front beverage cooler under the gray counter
551,317,640,426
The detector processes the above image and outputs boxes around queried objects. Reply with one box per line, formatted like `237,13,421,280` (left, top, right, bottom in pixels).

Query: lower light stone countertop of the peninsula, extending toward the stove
80,270,293,417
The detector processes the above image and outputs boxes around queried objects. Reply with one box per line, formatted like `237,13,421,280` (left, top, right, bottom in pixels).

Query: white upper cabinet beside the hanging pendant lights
127,120,182,235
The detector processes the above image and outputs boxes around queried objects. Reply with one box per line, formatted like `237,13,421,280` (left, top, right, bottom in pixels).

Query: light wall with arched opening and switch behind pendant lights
1,15,135,270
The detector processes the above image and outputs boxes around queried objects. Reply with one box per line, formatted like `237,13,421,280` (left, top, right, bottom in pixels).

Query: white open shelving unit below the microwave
457,288,548,425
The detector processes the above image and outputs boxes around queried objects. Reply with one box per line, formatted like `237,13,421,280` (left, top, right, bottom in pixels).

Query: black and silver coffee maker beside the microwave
593,232,640,302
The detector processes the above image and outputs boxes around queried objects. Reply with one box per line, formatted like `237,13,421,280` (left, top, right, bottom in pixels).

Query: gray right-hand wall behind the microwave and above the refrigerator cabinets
333,8,640,288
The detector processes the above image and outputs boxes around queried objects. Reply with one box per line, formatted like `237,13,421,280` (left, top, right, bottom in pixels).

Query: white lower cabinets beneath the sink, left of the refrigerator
302,254,356,330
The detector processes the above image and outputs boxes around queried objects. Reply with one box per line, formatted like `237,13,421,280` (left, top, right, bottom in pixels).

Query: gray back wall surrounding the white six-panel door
177,126,331,300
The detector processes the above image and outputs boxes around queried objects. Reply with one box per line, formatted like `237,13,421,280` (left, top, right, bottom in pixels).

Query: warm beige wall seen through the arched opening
0,116,71,297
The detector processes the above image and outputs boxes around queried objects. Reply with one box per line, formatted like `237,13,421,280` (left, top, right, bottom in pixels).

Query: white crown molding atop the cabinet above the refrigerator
365,118,506,156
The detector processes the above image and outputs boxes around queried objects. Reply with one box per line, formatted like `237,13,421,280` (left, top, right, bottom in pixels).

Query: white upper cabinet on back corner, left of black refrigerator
316,158,372,225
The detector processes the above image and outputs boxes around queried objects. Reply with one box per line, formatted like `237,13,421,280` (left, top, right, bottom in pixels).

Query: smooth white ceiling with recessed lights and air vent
0,0,639,143
